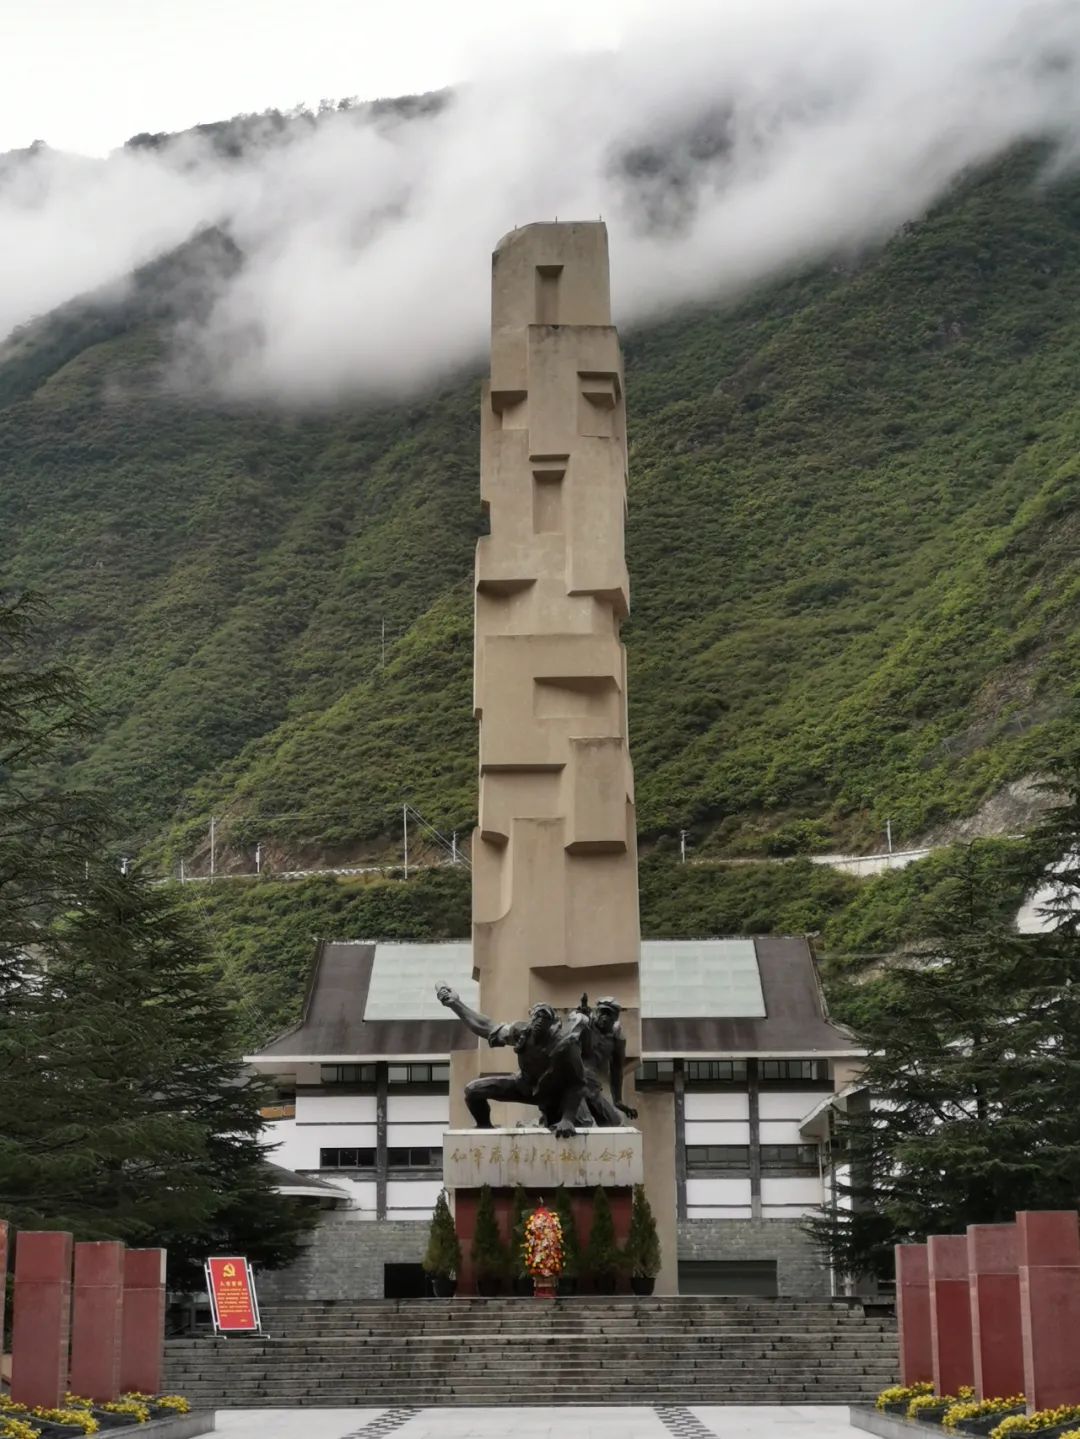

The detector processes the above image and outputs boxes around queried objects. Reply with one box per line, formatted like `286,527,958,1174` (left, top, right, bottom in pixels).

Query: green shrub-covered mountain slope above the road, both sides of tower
0,147,1080,863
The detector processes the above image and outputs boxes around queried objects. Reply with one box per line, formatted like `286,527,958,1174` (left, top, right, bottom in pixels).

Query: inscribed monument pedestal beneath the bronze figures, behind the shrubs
443,1125,644,1295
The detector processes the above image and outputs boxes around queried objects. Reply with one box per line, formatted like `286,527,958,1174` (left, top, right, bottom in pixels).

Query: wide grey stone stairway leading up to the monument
165,1298,897,1409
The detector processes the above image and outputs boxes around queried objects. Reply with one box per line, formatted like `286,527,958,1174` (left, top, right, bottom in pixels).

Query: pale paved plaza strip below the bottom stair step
217,1404,859,1439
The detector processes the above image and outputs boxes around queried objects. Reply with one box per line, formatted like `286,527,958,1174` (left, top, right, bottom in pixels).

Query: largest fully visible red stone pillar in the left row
12,1229,72,1409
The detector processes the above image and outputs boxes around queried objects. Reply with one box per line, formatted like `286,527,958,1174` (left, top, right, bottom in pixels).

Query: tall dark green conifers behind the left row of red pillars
0,589,308,1286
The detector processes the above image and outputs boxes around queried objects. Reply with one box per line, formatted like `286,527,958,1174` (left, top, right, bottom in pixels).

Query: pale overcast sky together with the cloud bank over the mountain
0,0,1080,403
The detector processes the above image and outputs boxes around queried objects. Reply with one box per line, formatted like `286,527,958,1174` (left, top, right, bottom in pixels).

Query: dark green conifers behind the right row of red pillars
808,836,1080,1275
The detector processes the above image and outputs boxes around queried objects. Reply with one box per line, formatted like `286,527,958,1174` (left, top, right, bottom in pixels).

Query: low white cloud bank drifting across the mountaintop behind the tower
0,0,1080,400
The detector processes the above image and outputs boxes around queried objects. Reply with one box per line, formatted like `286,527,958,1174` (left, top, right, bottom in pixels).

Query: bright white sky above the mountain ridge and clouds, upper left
0,0,684,154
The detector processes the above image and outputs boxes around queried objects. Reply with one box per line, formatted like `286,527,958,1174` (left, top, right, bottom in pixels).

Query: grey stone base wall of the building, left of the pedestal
256,1219,429,1302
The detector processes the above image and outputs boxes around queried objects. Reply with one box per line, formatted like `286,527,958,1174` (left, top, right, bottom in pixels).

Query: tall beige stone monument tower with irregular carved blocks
473,223,640,1033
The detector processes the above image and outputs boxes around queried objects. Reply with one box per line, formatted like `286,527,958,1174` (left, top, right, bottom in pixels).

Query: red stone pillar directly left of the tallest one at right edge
968,1225,1024,1399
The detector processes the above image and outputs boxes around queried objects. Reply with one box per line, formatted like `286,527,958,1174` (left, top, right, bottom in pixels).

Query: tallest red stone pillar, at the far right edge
1017,1209,1080,1410
